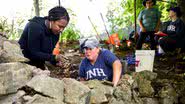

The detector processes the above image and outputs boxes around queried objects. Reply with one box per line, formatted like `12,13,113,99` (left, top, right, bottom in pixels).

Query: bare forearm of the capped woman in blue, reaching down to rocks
112,60,122,86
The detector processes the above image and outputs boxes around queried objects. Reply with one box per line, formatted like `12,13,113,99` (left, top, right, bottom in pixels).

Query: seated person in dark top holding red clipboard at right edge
156,7,185,54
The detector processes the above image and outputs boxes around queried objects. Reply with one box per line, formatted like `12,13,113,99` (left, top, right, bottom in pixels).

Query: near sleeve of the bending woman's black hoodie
28,22,55,61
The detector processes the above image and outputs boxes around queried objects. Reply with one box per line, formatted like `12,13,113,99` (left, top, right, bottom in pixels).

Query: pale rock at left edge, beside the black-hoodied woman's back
0,41,29,63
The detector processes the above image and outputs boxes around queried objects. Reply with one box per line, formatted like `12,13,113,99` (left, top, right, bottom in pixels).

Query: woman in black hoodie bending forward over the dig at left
18,6,70,69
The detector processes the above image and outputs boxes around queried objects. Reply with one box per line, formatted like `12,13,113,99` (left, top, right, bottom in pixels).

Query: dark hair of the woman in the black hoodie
48,6,70,22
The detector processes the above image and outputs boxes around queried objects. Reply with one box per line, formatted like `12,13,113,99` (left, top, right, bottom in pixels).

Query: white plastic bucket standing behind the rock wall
135,50,155,72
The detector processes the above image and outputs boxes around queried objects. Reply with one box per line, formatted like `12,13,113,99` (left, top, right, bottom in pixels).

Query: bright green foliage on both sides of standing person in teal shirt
106,0,176,32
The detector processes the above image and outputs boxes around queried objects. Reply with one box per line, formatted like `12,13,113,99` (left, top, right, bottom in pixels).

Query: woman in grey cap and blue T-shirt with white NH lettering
79,38,122,86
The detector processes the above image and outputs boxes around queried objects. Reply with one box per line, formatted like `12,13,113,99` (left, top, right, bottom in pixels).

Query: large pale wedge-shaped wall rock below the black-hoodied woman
26,75,64,101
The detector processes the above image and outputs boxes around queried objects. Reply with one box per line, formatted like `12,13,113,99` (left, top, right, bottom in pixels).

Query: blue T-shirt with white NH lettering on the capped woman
79,49,118,81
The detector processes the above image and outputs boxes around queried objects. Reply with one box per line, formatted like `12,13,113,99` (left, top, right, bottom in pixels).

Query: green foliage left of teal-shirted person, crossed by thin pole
107,0,144,31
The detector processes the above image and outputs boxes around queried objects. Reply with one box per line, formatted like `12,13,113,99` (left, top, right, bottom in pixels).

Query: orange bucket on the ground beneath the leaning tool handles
107,33,120,46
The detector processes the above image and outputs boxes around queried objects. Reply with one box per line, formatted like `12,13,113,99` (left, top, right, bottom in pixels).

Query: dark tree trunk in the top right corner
177,0,185,23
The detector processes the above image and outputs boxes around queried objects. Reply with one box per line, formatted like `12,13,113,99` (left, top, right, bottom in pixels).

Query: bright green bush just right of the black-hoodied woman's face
60,24,80,41
